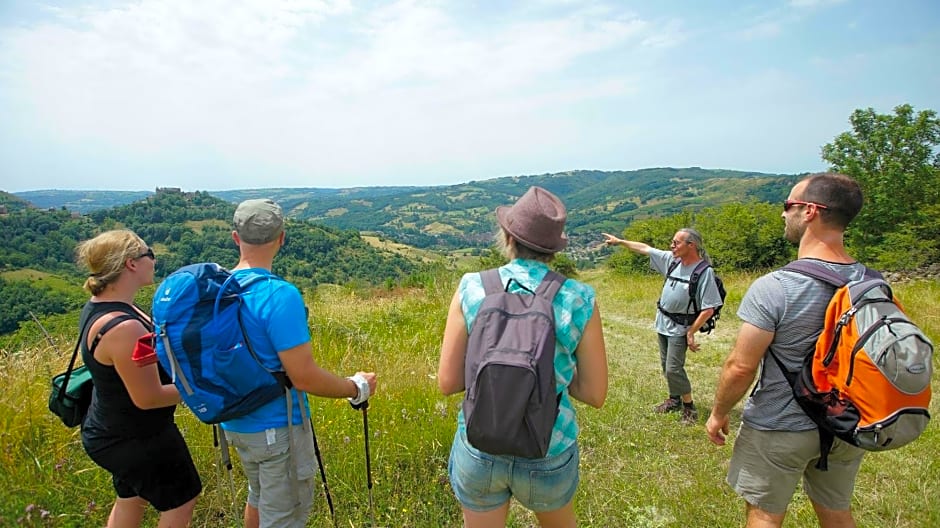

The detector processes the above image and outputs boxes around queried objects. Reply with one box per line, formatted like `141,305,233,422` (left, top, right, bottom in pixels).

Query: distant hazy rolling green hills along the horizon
7,167,799,253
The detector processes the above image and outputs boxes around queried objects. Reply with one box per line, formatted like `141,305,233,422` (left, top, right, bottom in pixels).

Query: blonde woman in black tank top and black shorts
76,230,202,528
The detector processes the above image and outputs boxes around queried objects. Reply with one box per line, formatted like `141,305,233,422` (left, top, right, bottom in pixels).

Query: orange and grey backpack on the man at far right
771,260,933,470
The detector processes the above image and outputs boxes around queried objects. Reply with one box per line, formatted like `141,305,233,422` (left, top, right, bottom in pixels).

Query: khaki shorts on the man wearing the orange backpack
728,424,865,514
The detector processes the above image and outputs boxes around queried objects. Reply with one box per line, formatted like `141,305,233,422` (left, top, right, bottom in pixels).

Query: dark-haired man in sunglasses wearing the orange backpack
705,173,865,528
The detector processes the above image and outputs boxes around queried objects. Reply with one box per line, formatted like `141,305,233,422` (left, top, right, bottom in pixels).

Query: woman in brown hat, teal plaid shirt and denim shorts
438,187,607,528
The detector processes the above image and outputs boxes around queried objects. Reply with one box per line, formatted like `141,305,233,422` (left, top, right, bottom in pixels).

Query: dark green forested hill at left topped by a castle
0,192,415,333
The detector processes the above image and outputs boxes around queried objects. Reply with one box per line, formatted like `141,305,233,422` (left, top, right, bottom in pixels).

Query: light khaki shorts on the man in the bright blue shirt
225,425,319,528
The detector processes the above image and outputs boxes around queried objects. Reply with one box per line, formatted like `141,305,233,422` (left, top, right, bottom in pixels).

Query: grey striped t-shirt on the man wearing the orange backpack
738,259,865,431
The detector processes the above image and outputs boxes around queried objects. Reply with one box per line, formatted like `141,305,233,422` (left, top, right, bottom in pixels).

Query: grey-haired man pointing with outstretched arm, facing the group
601,227,722,425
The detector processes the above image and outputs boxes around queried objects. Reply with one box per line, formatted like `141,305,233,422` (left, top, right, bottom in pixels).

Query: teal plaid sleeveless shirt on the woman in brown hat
457,259,594,457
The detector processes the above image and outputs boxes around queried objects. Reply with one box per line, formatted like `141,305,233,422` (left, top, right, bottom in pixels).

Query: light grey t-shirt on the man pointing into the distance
649,249,721,336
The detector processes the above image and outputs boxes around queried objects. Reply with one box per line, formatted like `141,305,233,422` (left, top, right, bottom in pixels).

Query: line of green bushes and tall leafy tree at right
609,104,940,271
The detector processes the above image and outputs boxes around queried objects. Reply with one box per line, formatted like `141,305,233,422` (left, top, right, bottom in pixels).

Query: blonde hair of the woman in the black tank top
75,229,147,295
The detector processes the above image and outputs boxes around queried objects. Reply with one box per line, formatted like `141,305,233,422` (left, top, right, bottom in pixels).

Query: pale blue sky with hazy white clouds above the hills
0,0,940,192
